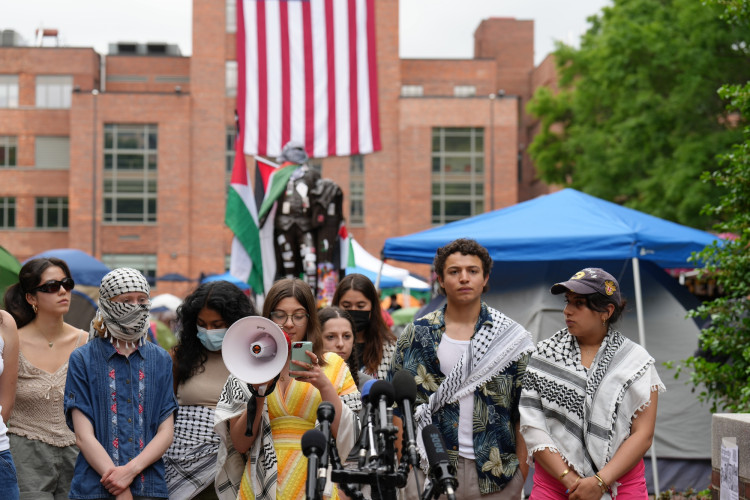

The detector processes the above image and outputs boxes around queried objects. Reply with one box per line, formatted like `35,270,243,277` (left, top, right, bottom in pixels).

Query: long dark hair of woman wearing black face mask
332,273,396,373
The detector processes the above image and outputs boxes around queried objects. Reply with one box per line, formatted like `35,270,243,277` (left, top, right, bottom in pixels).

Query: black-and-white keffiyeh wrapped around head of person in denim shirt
90,267,151,346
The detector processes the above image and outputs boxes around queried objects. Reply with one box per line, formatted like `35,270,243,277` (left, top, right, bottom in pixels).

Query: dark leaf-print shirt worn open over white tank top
388,302,530,495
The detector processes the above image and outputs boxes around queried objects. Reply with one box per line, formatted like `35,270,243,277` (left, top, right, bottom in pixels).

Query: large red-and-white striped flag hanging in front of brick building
237,0,381,158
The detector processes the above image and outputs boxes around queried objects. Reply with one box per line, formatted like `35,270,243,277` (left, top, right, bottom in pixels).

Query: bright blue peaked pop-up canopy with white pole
383,189,717,492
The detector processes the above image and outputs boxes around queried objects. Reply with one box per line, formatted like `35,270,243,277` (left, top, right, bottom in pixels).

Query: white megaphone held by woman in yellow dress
221,316,289,384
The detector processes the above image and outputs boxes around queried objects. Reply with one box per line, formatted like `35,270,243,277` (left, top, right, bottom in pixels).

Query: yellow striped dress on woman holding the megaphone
237,353,357,500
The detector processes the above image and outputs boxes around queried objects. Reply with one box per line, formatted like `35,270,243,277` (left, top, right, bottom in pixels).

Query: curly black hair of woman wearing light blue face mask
174,281,258,386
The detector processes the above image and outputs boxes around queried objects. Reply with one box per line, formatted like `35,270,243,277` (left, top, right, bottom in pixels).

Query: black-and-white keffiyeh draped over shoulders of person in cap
519,328,666,477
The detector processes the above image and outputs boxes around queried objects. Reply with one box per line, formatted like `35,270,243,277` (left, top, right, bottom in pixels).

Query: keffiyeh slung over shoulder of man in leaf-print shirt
414,307,534,473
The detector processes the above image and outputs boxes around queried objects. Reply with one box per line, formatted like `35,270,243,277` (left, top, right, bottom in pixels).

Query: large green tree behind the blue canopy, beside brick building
528,0,750,228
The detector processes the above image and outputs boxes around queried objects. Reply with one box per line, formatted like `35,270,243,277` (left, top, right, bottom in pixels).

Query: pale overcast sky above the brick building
0,0,611,63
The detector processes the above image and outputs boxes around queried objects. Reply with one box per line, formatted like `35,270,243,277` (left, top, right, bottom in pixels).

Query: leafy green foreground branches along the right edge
685,0,750,412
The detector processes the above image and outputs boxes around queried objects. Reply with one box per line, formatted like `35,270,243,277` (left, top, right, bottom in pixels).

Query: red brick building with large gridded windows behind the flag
0,0,549,294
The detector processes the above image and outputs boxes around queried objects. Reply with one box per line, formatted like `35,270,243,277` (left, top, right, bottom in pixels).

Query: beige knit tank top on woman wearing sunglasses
8,332,86,447
